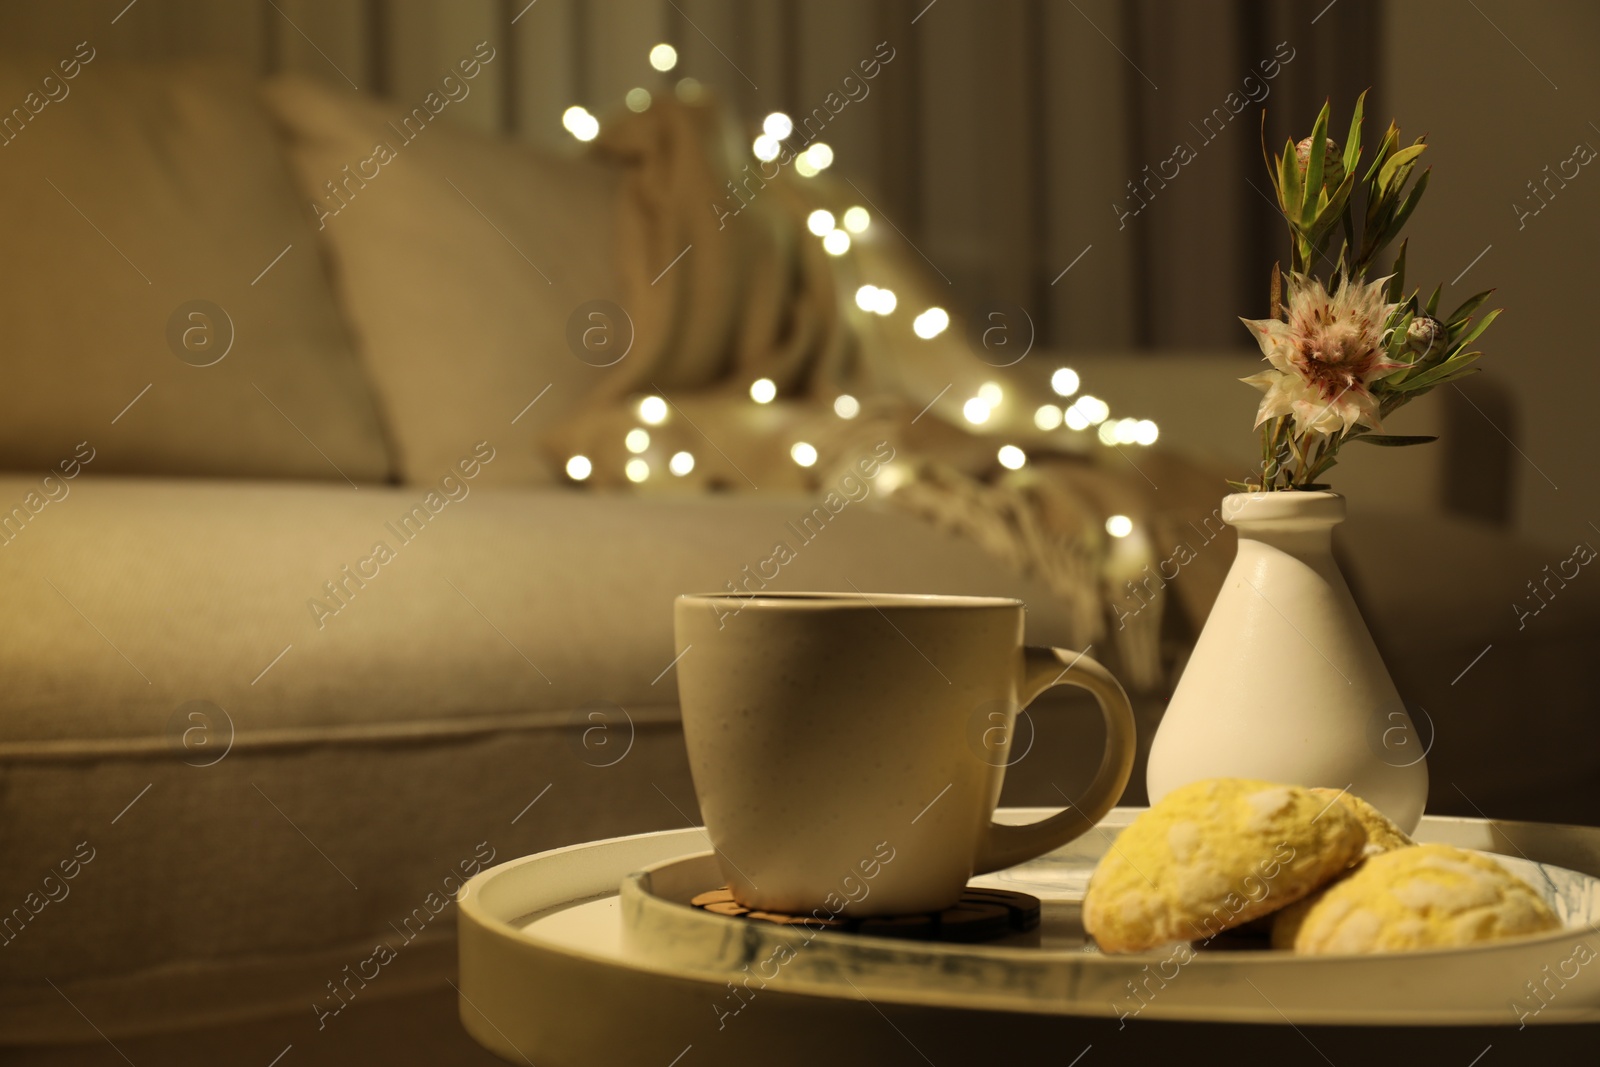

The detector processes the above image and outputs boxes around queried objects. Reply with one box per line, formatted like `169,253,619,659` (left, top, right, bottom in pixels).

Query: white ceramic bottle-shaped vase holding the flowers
1147,491,1432,832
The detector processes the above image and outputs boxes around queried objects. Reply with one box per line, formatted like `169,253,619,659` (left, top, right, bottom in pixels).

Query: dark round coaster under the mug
690,886,1038,944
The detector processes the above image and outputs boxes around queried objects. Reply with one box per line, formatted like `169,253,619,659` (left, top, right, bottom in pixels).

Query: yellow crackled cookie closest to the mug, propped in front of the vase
1083,777,1366,952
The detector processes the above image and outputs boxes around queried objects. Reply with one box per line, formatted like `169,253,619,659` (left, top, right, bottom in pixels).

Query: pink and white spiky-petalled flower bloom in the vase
1240,274,1405,435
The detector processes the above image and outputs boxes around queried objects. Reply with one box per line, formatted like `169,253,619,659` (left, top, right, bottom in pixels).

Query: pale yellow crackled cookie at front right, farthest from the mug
1272,845,1560,955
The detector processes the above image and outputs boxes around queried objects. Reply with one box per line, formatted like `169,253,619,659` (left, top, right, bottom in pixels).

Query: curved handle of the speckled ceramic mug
973,648,1134,875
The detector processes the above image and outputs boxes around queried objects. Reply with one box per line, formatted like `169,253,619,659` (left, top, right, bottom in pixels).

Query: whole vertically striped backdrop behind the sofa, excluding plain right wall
0,0,1378,358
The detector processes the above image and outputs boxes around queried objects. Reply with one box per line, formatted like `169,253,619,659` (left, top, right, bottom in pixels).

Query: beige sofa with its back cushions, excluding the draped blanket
0,69,1600,1064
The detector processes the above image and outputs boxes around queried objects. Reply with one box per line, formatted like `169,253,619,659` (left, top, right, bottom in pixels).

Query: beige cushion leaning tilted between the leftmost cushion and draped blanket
266,78,619,485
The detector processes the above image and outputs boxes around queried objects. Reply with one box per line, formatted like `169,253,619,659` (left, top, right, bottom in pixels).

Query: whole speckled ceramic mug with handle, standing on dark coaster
674,593,1134,918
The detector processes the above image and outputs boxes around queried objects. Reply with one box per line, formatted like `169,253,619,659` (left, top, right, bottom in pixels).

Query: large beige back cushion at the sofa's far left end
0,62,389,483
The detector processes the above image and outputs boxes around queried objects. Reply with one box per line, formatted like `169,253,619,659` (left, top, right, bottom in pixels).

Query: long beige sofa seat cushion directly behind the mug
0,470,1070,753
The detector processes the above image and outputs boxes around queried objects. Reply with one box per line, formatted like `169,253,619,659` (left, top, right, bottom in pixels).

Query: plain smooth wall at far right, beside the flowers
1384,0,1600,550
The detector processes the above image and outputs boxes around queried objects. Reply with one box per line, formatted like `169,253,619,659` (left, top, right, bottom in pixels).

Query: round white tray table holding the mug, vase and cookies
459,808,1600,1067
